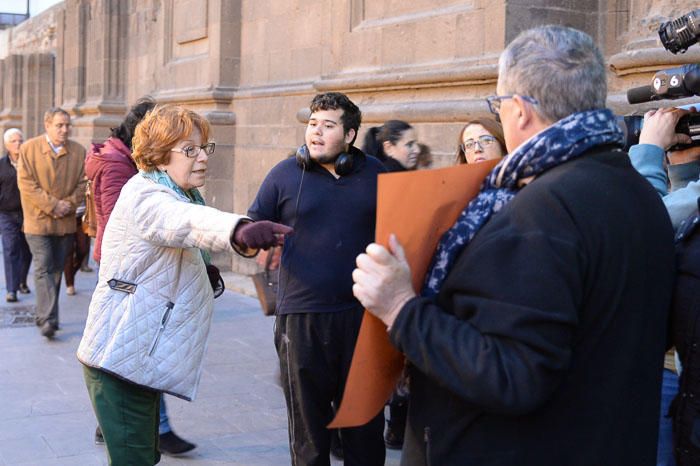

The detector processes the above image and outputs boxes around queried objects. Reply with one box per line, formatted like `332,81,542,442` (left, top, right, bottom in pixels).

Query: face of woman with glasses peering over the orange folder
455,118,507,164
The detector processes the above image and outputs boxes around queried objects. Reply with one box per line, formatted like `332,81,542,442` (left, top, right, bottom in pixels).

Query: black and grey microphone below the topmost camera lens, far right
627,65,700,104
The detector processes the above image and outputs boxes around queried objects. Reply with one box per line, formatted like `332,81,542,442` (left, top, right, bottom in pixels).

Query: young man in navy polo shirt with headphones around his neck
248,92,385,466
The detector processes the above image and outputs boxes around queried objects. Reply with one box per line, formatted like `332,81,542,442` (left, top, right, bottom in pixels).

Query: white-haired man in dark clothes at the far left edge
0,128,32,303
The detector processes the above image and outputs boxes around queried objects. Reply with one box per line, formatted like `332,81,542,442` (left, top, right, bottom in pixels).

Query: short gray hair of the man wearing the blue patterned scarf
498,25,608,122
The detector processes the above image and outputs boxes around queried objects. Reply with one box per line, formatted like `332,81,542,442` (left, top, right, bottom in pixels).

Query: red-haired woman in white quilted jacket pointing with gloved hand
78,105,291,466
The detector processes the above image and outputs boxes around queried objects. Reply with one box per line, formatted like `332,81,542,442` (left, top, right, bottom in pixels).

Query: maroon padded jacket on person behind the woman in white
85,137,138,262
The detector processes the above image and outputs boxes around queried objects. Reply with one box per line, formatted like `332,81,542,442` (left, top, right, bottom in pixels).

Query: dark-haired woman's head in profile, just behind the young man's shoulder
362,120,420,172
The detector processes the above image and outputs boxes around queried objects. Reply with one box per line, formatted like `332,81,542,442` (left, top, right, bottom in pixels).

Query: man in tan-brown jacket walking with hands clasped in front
17,108,85,338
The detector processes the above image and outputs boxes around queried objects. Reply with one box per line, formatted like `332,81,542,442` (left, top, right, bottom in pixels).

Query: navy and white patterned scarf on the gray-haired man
422,109,623,297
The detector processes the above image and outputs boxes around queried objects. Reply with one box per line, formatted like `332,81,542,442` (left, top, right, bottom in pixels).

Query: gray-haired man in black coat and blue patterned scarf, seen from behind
353,26,674,466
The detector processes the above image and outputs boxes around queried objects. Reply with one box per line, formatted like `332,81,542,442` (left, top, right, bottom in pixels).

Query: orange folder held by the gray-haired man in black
328,160,498,428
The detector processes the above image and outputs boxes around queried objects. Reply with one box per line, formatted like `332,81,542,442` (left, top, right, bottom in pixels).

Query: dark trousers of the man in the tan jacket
26,234,73,327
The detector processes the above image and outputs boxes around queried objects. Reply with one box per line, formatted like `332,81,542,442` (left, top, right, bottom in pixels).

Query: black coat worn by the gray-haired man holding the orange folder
390,149,674,466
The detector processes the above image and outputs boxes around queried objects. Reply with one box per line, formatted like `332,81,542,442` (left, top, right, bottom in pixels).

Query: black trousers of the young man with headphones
275,309,386,466
